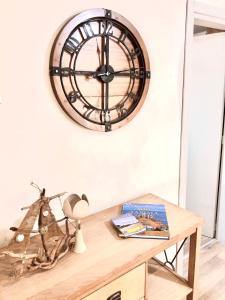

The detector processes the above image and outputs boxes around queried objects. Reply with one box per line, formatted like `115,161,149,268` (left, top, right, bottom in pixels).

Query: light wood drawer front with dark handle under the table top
83,264,145,300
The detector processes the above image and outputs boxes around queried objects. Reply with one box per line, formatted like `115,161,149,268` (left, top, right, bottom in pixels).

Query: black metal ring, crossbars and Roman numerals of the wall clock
50,10,151,131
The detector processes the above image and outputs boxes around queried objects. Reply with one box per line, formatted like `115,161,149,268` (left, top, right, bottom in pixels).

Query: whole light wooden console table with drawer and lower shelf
0,194,203,300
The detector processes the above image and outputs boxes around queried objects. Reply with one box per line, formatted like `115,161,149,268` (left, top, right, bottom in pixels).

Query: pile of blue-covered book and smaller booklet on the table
112,203,170,240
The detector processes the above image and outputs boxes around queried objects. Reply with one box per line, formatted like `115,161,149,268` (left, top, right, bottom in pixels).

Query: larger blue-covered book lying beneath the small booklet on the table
122,203,169,239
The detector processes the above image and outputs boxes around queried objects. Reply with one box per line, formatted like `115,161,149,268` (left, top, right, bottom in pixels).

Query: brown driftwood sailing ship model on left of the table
0,184,79,277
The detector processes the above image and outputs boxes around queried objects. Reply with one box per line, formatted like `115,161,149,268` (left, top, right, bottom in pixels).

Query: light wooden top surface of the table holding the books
0,194,203,300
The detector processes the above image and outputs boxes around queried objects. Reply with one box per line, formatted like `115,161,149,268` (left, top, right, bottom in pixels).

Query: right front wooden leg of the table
187,227,201,300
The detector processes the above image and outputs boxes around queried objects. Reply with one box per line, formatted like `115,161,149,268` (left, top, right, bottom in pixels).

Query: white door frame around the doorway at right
178,0,225,243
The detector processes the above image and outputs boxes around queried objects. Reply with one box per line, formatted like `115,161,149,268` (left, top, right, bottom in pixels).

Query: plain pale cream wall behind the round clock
0,0,186,244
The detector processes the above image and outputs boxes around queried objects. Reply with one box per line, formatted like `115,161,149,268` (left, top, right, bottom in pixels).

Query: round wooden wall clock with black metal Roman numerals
50,9,150,131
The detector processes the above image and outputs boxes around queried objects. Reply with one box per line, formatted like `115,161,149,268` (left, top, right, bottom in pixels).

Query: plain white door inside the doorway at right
187,33,225,237
